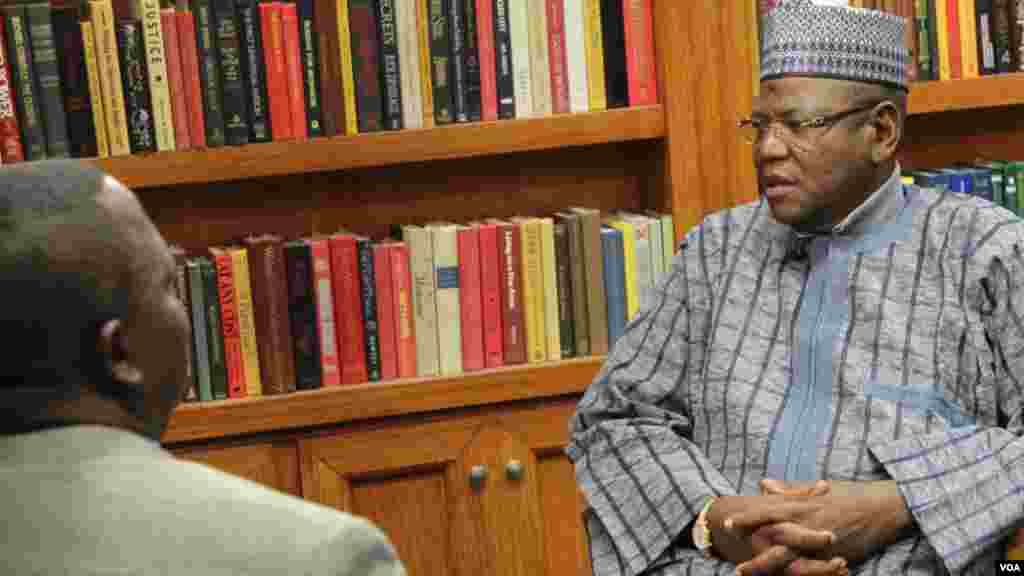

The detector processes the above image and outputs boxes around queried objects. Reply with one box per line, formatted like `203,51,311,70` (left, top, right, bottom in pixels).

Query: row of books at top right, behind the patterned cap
851,0,1024,80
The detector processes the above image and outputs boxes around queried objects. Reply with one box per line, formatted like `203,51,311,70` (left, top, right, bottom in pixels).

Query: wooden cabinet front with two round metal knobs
299,397,590,576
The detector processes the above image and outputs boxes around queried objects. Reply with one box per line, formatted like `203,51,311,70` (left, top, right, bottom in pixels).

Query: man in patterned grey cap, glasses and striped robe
566,0,1024,576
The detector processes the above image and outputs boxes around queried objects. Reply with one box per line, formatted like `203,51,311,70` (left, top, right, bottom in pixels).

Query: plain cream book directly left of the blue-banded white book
401,225,439,376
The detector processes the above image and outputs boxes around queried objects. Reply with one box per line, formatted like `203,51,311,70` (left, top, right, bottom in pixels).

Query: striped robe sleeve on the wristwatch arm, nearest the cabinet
566,231,735,576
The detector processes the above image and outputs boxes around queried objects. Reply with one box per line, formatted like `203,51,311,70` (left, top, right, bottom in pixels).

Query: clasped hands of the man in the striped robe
708,480,913,576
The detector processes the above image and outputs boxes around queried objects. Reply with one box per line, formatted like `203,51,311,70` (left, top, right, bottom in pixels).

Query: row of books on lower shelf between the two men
176,208,675,402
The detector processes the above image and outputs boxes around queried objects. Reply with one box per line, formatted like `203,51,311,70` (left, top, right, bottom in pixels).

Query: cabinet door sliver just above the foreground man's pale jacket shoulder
170,441,302,496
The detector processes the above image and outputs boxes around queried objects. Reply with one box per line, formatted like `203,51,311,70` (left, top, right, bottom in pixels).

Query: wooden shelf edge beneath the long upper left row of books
91,106,665,189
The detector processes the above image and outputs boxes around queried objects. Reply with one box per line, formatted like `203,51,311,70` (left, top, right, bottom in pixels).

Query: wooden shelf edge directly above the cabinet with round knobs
162,357,604,445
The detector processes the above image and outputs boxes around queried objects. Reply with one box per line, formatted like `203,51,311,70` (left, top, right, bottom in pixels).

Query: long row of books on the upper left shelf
0,0,657,163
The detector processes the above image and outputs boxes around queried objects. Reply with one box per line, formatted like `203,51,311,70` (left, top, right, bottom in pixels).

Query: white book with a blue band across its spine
430,224,462,376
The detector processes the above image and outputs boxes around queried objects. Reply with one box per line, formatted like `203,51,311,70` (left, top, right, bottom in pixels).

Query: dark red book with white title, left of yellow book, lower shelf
495,220,526,365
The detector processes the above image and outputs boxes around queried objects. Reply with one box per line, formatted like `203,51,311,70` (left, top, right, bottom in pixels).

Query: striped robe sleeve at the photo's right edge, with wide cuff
869,227,1024,574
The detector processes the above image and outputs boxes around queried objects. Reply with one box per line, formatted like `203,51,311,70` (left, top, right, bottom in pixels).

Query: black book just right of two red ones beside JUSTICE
193,0,226,148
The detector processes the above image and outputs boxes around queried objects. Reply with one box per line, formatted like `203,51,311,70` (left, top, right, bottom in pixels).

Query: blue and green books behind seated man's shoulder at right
903,160,1024,213
